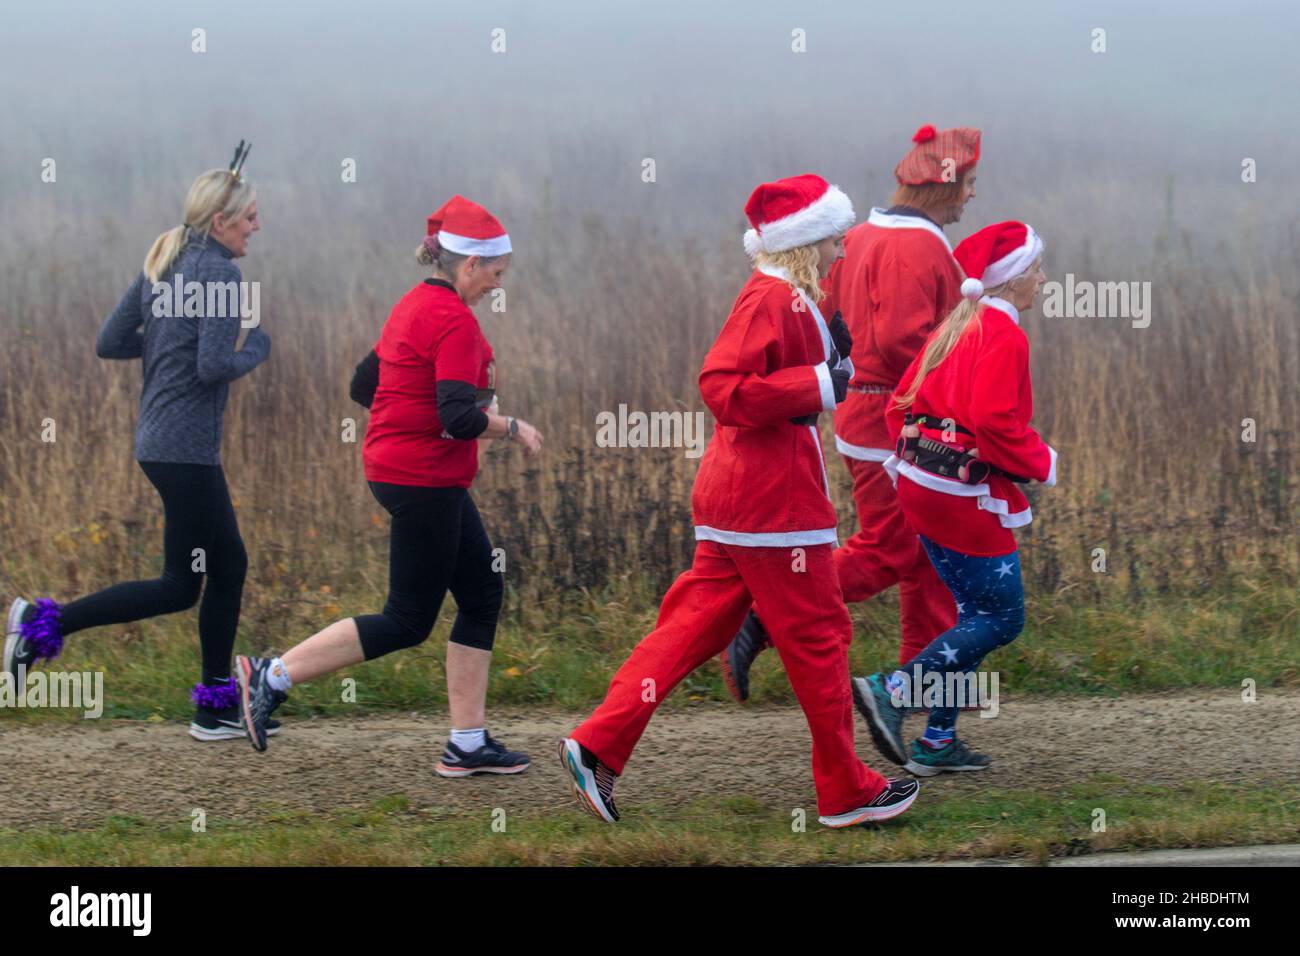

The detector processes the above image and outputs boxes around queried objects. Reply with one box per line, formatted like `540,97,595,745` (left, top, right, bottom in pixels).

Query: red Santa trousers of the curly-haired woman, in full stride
573,538,887,816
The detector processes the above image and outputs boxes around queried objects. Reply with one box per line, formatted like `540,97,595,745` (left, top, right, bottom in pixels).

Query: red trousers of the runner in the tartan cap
835,457,957,663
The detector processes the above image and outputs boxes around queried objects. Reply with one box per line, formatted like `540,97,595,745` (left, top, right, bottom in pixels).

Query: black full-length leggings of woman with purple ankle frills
60,462,248,684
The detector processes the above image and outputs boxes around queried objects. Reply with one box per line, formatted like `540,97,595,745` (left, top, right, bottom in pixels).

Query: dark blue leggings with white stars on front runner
901,536,1024,740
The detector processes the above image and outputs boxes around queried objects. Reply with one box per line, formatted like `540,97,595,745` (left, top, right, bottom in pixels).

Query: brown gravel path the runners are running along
0,688,1300,829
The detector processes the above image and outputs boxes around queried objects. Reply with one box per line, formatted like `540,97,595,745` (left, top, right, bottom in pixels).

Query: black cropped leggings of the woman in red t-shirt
355,481,503,661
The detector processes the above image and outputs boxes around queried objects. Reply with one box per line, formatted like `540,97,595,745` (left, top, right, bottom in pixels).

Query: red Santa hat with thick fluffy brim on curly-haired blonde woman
745,173,854,259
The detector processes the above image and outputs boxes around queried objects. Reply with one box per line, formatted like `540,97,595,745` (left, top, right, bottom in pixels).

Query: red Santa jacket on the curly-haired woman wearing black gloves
690,269,837,548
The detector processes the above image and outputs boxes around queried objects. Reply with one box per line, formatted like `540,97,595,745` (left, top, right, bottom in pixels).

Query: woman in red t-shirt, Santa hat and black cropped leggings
235,196,542,777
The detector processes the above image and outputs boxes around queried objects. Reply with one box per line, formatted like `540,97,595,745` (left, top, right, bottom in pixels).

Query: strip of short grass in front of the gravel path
0,777,1300,866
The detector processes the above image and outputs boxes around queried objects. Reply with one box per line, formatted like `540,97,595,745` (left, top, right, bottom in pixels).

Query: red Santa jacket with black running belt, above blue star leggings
884,297,1057,555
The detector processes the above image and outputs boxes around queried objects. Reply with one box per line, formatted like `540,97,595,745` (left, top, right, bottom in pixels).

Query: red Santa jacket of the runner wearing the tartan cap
822,209,965,462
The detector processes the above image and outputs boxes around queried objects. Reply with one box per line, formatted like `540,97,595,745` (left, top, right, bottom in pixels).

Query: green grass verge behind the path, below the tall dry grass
3,567,1300,721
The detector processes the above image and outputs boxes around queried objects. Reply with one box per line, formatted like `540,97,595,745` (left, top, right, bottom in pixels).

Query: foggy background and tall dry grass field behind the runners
0,0,1300,708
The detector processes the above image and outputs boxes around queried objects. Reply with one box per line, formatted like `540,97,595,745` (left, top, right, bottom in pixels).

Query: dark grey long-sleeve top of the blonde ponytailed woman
95,238,270,464
